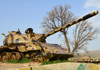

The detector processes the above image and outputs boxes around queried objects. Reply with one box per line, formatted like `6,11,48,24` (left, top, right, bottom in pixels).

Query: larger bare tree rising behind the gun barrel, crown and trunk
42,5,74,52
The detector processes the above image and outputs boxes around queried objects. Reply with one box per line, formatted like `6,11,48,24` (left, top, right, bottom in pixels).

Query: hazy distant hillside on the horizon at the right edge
75,50,100,58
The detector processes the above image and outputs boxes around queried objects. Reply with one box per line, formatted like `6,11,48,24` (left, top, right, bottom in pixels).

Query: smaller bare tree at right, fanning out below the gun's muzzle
71,21,98,53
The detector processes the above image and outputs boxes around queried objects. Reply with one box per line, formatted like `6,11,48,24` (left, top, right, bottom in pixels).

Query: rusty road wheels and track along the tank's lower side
0,52,53,62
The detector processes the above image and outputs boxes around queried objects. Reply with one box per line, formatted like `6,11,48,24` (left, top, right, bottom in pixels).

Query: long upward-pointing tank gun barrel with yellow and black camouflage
44,11,99,38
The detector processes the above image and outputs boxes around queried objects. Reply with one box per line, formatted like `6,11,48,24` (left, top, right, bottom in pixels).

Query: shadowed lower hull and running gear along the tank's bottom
0,46,72,62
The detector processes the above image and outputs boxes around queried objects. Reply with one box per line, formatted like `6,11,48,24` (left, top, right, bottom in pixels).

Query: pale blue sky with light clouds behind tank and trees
0,0,100,50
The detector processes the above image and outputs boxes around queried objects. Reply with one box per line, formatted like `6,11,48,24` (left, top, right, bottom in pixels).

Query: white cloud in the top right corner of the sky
84,0,100,9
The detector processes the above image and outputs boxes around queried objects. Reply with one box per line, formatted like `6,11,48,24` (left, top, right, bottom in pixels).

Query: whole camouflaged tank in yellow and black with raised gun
0,11,98,62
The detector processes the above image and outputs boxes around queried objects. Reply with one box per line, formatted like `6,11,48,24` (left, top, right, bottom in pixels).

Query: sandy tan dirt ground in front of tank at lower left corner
0,62,41,70
